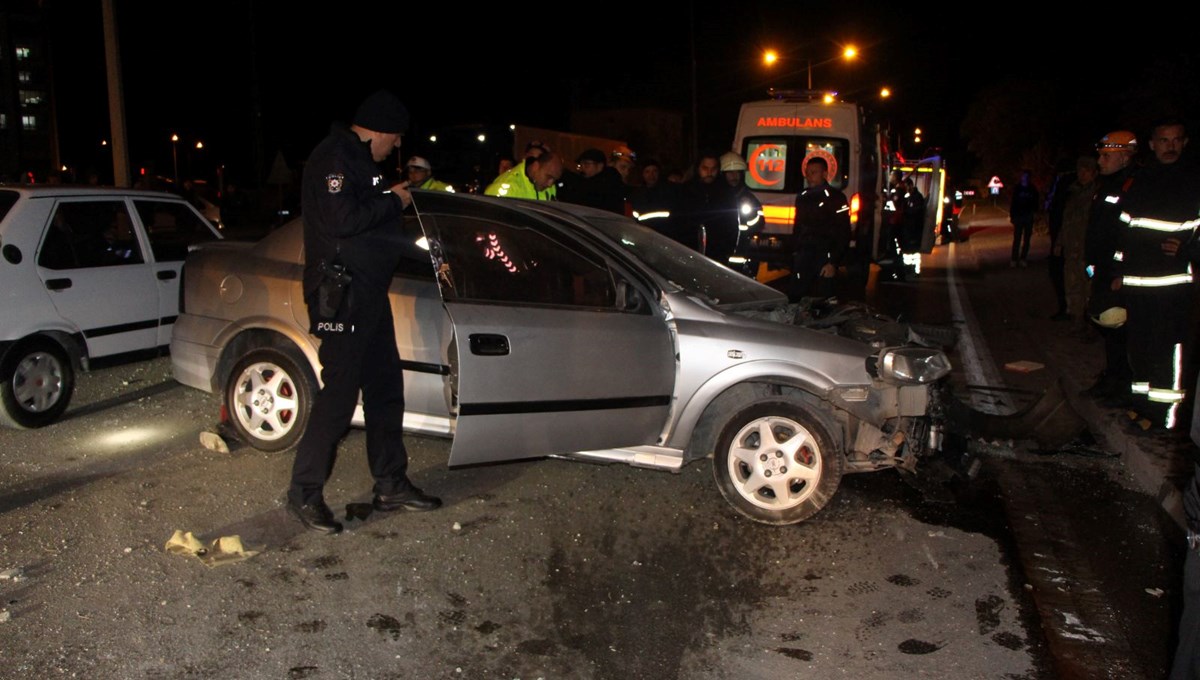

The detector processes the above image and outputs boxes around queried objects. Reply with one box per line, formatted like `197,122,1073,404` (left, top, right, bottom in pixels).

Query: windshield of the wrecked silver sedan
587,216,787,309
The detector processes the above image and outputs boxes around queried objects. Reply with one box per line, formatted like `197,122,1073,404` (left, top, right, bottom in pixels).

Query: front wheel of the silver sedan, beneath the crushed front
713,402,845,525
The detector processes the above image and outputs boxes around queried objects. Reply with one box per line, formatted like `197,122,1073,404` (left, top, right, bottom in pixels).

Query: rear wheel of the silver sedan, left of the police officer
224,348,317,451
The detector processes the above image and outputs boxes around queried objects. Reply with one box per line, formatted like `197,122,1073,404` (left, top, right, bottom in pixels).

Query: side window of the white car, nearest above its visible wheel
37,200,145,270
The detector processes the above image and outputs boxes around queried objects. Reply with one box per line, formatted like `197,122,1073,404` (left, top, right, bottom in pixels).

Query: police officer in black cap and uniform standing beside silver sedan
287,90,442,534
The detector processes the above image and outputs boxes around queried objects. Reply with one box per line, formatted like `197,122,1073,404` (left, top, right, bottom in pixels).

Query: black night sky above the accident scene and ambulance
47,0,1185,185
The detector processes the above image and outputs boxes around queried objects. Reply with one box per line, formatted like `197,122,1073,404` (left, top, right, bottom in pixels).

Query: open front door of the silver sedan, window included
413,192,676,465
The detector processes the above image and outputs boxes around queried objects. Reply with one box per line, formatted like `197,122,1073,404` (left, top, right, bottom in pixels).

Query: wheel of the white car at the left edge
0,338,74,429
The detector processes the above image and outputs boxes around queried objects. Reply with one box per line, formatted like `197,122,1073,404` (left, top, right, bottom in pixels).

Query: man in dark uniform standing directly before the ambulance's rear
788,156,850,302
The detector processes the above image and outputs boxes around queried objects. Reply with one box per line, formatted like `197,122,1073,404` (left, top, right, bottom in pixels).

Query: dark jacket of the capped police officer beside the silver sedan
300,124,403,324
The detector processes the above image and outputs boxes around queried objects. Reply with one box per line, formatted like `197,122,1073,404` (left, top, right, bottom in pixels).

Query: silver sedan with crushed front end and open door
170,191,950,524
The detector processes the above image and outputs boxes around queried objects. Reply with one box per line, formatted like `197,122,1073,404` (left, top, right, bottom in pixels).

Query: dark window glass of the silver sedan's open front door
437,215,617,307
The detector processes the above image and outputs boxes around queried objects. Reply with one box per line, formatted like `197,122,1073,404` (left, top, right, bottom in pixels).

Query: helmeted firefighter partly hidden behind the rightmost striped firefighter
1084,130,1138,407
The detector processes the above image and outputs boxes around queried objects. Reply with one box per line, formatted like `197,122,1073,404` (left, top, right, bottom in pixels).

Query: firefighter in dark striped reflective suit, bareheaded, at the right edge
1114,120,1200,433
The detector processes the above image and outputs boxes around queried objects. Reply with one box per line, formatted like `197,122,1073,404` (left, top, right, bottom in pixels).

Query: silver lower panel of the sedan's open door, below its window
446,302,674,465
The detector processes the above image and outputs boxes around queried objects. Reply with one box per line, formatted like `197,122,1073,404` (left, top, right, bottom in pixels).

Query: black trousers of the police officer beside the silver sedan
288,301,412,504
